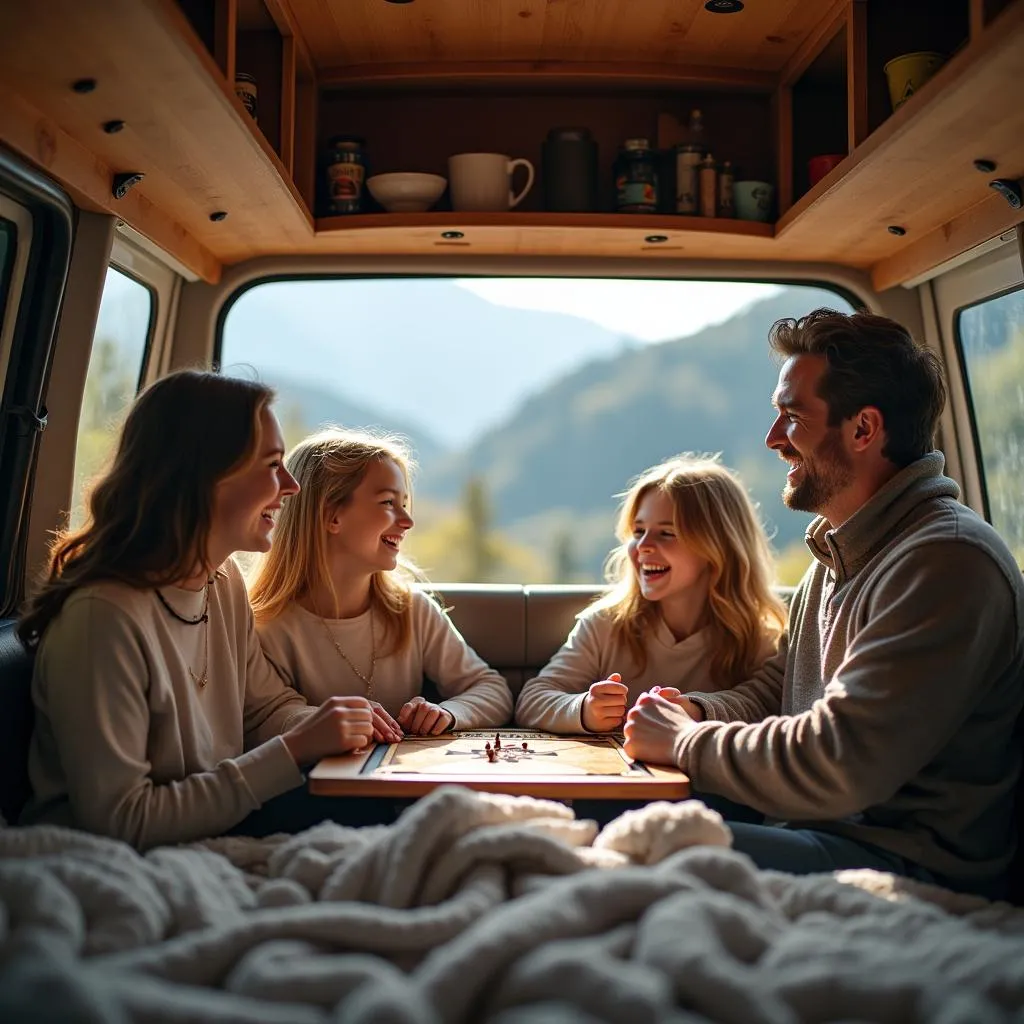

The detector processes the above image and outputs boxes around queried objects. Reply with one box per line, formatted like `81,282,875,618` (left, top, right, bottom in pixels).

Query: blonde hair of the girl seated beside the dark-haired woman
249,427,418,651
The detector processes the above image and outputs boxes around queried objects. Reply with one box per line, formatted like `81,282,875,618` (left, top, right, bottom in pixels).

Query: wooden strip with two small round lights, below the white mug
314,211,775,259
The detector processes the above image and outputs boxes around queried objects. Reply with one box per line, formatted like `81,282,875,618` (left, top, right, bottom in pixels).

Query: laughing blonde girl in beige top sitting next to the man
516,454,785,733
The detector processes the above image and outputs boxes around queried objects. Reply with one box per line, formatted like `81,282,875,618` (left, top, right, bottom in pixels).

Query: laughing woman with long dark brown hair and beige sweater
18,371,373,849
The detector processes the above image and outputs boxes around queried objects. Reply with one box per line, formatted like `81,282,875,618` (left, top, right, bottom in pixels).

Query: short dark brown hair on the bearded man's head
768,309,946,468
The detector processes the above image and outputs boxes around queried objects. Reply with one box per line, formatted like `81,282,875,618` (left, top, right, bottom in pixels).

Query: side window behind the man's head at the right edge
956,289,1024,564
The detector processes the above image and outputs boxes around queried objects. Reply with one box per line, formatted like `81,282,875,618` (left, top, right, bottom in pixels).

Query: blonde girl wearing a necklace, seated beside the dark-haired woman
250,427,512,740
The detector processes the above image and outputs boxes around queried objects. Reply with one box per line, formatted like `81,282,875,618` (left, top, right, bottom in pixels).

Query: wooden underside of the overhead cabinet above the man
775,3,1024,289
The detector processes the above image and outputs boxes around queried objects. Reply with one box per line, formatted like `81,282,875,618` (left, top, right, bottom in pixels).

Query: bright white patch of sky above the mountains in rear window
458,278,779,341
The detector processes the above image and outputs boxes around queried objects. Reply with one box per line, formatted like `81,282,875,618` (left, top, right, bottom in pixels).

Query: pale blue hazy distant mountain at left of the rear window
221,278,637,447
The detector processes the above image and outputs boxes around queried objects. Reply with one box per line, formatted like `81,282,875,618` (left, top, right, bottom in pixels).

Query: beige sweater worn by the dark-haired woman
23,561,313,849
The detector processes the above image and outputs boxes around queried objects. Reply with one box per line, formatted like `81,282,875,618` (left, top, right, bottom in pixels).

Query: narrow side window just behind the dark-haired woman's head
71,266,156,527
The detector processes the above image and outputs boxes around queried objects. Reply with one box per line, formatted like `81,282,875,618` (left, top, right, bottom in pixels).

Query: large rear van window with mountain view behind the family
219,278,852,584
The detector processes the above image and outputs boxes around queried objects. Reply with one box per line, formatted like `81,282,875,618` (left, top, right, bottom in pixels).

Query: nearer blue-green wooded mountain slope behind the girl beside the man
421,289,836,566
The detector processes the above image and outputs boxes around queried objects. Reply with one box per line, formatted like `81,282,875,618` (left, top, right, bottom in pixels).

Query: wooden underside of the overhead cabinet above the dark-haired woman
0,0,312,280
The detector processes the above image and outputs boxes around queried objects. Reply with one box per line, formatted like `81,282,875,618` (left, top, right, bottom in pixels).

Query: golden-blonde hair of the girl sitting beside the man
595,453,786,686
